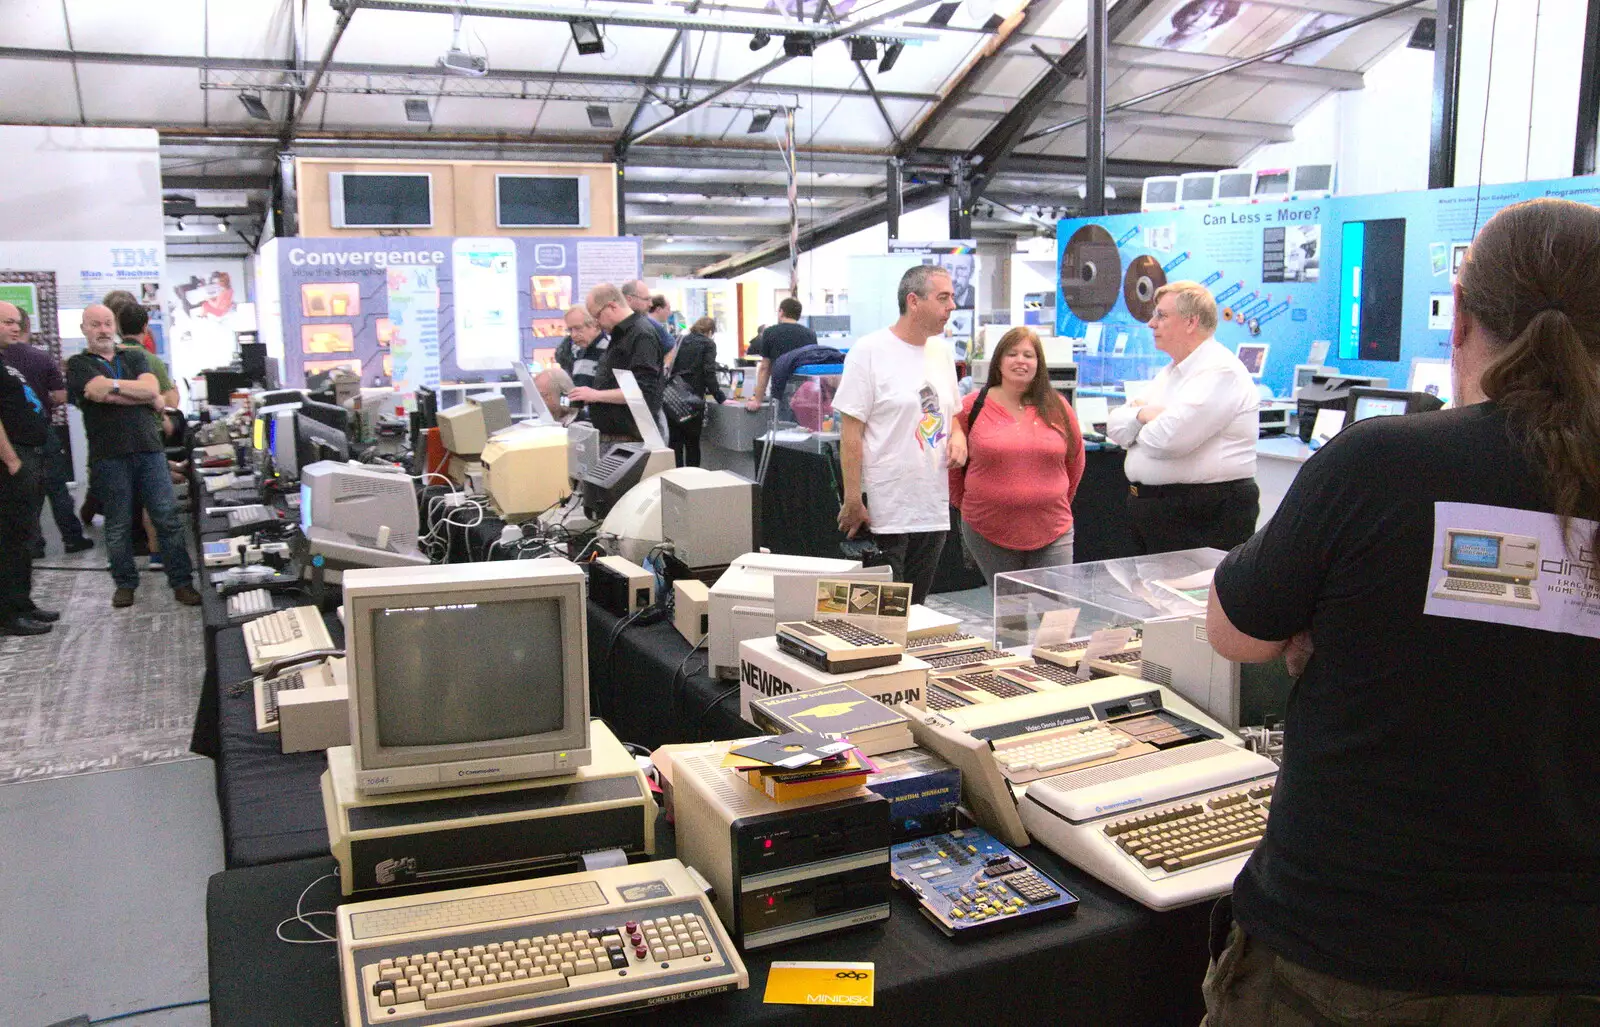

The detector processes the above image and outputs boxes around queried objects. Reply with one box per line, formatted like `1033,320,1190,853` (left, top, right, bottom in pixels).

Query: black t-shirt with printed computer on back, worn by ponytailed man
1214,403,1600,993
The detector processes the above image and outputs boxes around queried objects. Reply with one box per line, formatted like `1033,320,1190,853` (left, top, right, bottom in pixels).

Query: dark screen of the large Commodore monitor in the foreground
371,598,565,749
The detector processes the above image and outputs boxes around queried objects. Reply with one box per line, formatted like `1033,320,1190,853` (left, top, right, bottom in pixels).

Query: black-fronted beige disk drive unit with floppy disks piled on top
674,753,890,950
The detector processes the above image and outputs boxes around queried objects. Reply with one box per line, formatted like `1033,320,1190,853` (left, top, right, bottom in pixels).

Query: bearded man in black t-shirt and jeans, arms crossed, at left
67,304,200,608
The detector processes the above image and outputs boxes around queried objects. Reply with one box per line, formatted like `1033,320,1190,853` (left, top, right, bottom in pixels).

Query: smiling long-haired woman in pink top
950,328,1083,584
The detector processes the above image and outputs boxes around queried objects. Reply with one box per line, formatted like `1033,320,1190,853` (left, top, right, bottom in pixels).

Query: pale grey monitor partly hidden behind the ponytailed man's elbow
1139,614,1294,731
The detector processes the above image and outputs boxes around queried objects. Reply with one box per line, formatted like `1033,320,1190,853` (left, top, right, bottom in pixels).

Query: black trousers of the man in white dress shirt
1128,478,1261,553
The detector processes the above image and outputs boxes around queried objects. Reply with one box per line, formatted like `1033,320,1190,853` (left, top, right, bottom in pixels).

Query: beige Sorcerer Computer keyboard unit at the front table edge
336,859,749,1027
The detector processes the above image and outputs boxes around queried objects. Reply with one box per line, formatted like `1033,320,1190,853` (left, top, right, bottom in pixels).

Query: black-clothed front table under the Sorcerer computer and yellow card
206,846,1210,1027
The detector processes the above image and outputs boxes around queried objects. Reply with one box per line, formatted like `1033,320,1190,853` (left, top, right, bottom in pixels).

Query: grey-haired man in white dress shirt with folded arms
1106,282,1261,553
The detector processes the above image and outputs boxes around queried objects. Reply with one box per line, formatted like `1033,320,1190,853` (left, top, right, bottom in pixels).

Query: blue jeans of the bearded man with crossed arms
90,453,194,589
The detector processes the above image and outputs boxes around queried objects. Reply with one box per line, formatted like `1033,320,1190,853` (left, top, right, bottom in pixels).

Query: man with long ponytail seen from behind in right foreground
1205,193,1600,1027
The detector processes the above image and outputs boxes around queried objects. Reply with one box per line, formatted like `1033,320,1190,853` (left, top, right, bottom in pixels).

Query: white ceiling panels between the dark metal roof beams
0,0,1430,270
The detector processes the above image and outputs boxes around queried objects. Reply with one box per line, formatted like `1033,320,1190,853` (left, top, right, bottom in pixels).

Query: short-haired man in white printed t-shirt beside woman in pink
834,264,966,603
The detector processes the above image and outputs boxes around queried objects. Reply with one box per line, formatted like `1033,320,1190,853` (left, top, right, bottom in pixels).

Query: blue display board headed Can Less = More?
1056,178,1600,395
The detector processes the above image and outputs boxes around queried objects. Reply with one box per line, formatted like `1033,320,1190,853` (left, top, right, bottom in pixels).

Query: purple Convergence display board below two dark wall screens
267,237,643,387
